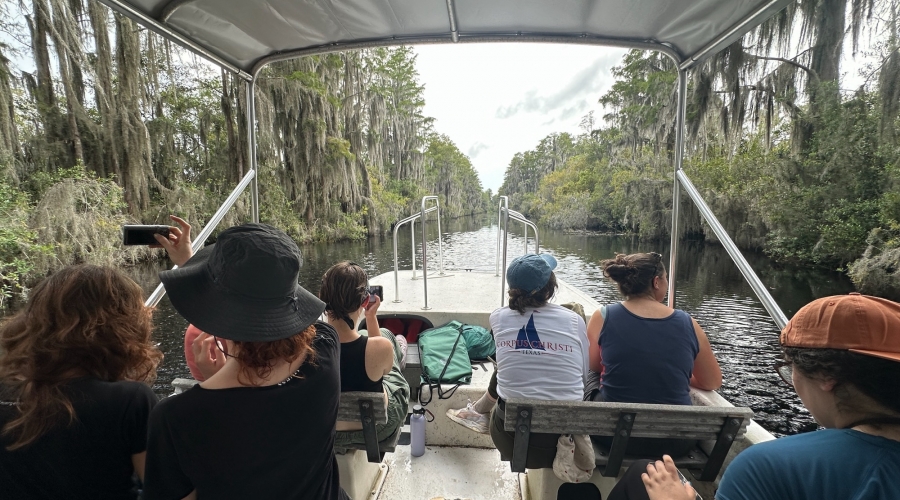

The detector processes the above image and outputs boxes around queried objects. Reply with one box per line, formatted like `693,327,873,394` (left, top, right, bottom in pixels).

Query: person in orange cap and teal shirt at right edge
610,293,900,500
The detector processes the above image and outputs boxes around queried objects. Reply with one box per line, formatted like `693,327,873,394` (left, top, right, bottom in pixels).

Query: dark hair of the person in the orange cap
782,347,900,413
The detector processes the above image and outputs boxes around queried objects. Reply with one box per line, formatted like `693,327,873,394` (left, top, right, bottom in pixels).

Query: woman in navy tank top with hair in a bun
585,252,722,456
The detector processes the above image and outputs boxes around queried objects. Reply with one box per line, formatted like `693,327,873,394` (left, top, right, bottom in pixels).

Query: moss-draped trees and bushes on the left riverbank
0,0,490,310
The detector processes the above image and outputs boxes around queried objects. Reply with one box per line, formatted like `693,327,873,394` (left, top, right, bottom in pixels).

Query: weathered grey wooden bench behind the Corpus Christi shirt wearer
504,399,753,481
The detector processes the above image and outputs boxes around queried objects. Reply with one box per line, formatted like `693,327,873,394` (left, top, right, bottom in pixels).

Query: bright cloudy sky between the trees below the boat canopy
414,43,625,193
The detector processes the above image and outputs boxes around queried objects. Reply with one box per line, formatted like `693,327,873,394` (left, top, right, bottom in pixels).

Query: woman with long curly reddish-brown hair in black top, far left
0,265,162,499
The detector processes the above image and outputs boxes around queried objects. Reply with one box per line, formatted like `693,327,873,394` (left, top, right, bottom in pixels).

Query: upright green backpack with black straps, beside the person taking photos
419,321,472,406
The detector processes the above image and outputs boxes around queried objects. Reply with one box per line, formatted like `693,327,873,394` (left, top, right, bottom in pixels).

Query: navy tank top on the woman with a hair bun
600,303,700,405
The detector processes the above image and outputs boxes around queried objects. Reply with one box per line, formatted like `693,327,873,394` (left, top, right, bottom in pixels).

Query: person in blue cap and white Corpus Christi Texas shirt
469,254,588,469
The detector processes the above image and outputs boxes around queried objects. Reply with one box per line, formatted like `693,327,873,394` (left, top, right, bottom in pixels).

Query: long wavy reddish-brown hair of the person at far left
0,265,163,451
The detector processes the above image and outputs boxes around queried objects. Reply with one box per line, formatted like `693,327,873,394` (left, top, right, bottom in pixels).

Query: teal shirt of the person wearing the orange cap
716,429,900,500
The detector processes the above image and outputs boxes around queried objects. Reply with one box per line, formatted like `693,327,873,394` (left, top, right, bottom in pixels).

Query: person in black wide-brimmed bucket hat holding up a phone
144,217,347,500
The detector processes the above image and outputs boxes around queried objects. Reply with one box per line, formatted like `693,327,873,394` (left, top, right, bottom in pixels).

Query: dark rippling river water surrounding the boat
134,216,853,435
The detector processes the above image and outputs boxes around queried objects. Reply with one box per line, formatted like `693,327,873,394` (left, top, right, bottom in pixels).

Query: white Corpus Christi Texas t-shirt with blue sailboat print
491,304,588,401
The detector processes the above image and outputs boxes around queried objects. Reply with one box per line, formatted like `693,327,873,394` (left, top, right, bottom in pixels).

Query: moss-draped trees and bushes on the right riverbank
499,0,900,300
